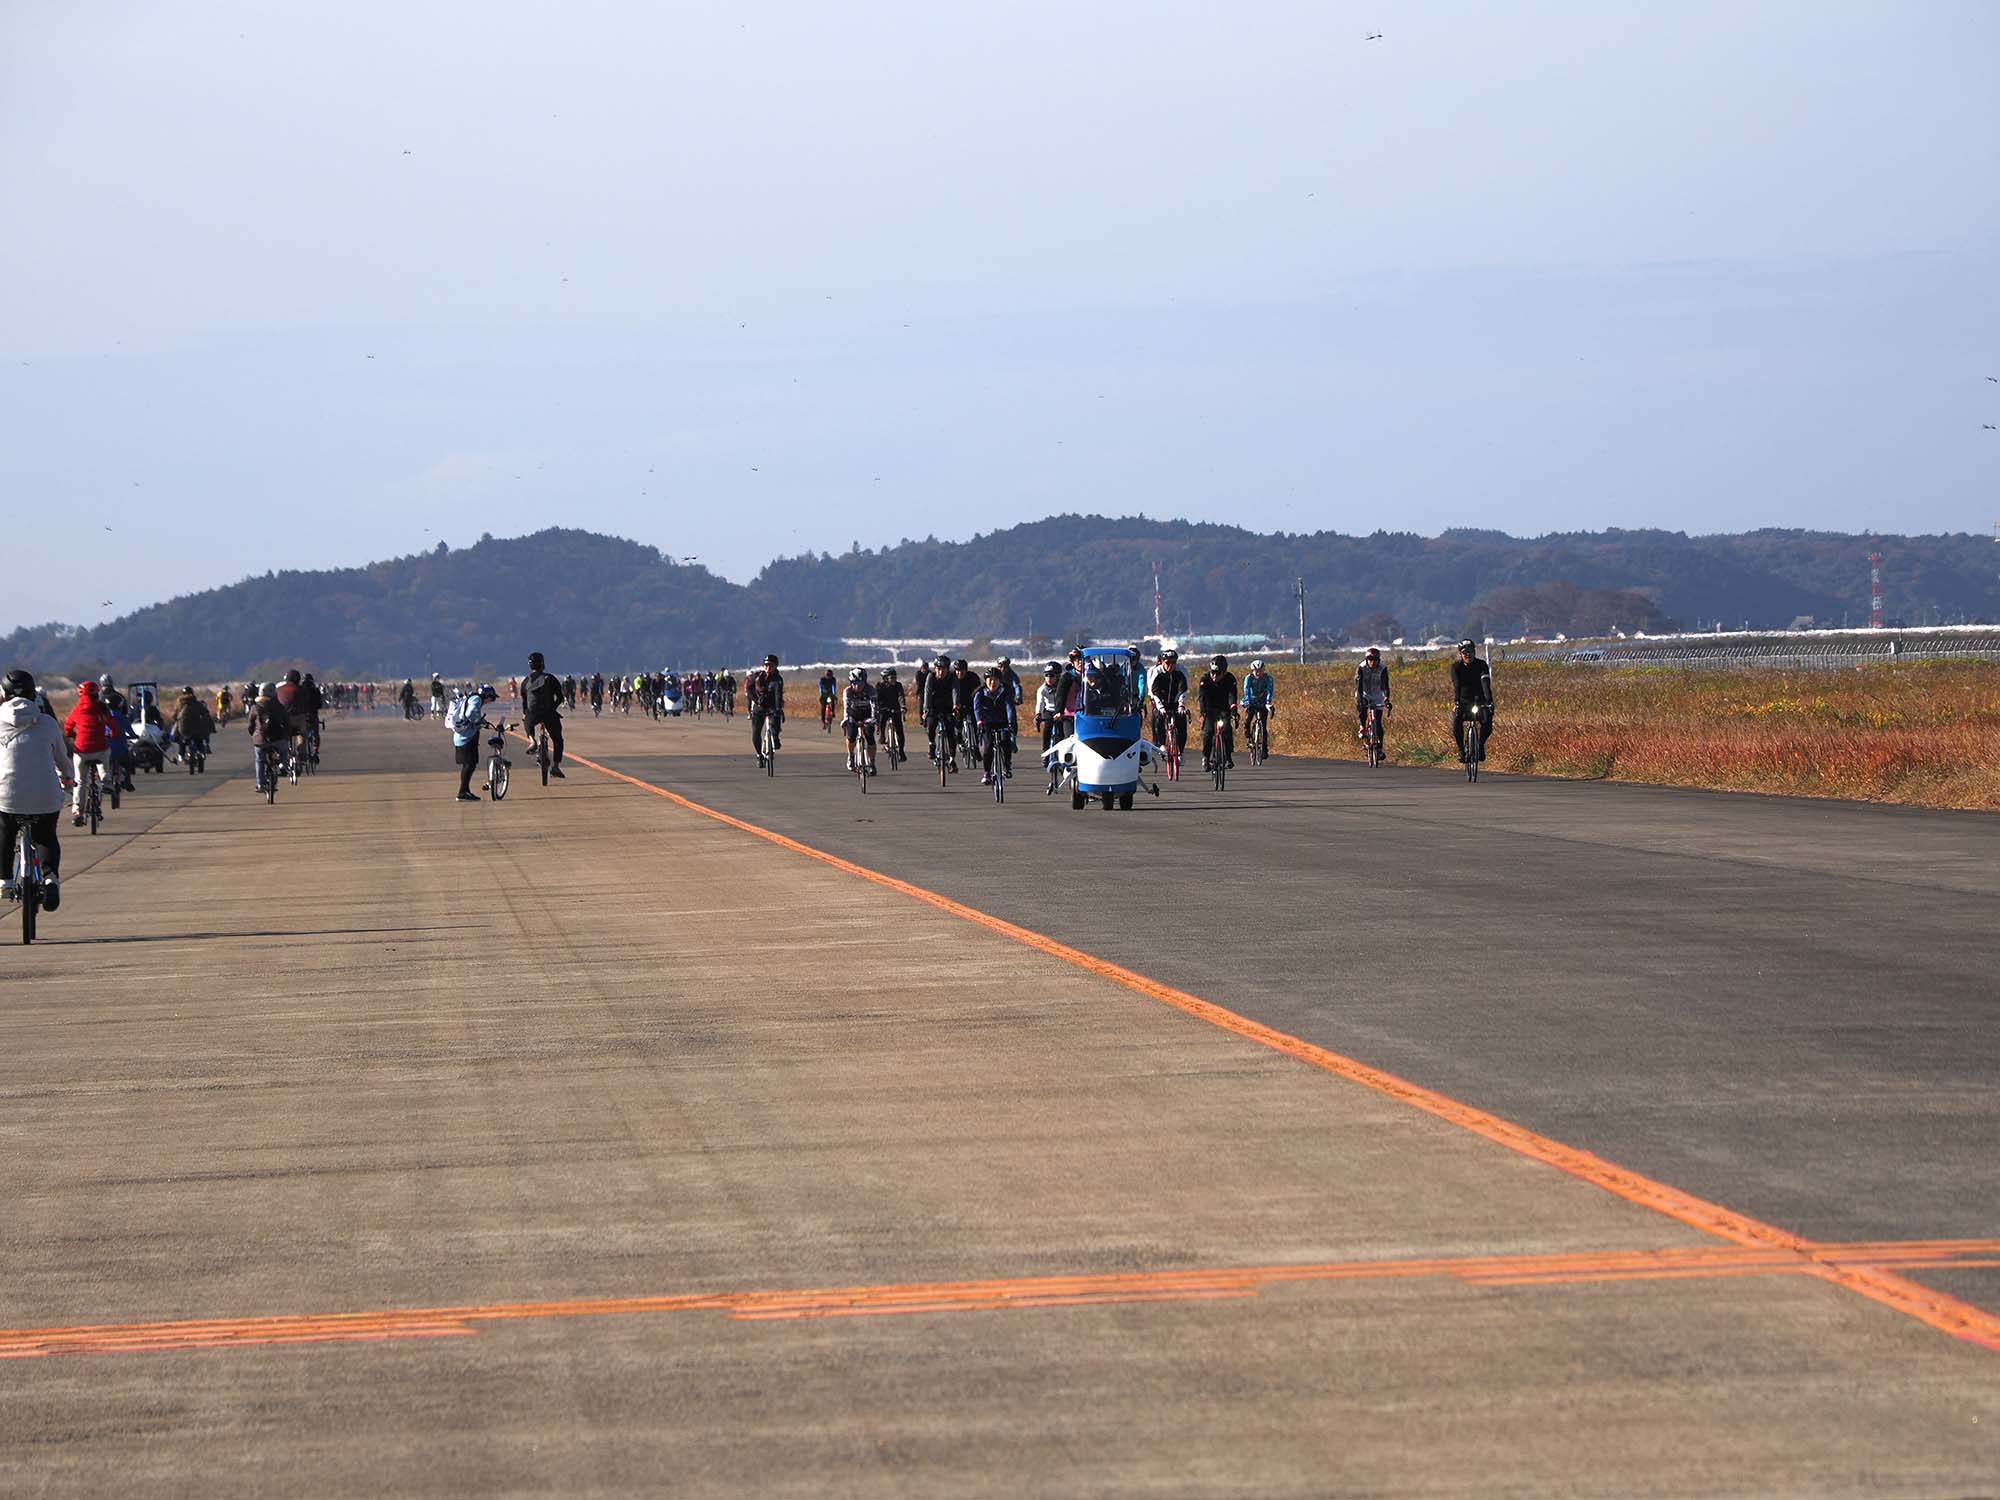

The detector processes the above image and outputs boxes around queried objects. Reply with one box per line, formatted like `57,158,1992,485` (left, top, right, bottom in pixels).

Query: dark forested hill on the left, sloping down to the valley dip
0,530,828,678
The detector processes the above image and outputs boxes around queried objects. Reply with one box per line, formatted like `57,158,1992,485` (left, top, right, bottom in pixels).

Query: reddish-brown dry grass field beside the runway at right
1272,660,2000,810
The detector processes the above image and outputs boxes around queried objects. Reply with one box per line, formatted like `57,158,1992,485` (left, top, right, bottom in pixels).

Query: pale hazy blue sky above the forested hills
0,0,2000,630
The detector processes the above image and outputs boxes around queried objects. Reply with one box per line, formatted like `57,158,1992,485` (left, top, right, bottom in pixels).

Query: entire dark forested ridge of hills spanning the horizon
0,516,2000,678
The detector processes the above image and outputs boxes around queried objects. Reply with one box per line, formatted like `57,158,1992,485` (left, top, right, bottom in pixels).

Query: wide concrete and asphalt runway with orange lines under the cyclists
0,714,2000,1496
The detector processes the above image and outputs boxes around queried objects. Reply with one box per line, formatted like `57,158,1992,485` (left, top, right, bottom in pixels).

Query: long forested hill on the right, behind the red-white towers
752,516,2000,640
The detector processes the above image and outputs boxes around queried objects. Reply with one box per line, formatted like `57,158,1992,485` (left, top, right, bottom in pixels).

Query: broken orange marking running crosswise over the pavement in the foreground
0,1240,2000,1360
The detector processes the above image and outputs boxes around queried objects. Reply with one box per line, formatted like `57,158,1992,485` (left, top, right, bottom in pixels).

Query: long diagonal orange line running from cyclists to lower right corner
566,756,2000,1352
